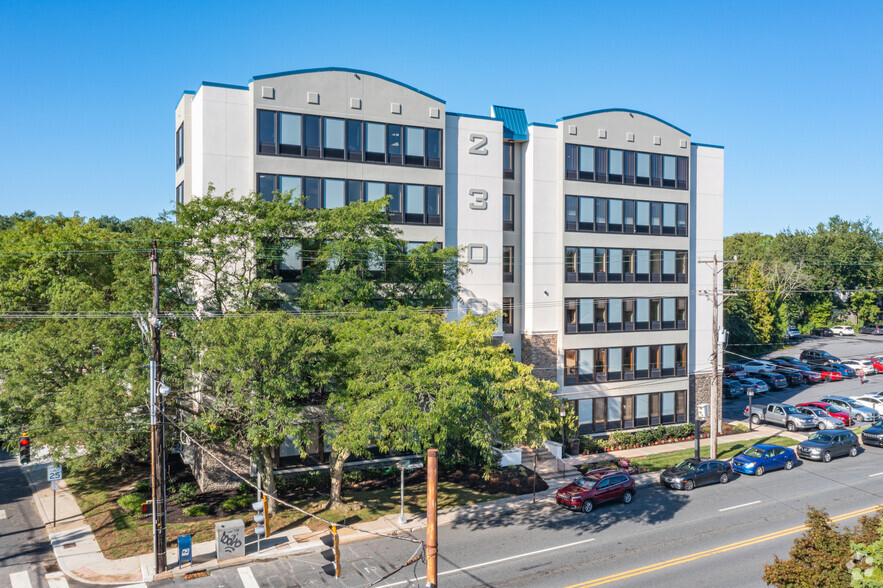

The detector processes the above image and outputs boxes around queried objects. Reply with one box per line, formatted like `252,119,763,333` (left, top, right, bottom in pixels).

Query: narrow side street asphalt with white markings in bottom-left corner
0,451,55,588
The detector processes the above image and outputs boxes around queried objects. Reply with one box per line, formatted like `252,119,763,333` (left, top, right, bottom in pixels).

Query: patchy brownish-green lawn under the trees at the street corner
66,471,512,559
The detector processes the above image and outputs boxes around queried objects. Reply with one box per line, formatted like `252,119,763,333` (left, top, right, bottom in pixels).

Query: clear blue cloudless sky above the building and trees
0,0,883,234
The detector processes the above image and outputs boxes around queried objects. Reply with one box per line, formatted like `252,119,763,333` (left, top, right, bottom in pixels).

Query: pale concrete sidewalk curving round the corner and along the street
24,426,806,585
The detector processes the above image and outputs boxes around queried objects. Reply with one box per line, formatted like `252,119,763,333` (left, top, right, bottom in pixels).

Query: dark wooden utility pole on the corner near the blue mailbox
148,241,166,574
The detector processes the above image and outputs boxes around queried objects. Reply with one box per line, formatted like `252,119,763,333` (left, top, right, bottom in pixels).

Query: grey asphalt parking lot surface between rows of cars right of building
723,335,883,425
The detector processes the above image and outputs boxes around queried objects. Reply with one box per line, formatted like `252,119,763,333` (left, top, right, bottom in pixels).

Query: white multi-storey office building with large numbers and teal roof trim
175,69,724,434
